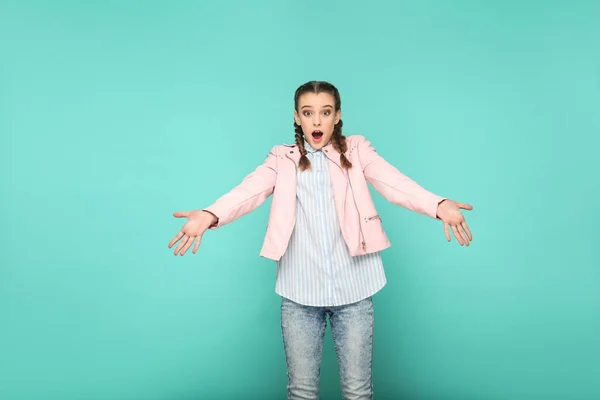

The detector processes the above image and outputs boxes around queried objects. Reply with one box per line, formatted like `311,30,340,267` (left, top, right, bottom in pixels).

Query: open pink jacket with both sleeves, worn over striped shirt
204,135,444,261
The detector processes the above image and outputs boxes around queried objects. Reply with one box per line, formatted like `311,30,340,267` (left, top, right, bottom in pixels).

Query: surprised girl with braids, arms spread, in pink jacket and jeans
169,81,473,399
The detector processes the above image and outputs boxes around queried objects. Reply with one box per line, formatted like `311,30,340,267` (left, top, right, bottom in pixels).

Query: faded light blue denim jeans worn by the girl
281,297,374,400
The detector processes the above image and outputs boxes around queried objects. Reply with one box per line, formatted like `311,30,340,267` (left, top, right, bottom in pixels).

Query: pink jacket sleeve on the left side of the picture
203,147,277,229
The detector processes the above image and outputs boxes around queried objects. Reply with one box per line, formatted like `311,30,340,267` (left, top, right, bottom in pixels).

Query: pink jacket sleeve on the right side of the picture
357,136,446,218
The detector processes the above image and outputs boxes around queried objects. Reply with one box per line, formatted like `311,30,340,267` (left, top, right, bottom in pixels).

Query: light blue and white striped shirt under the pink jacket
275,141,386,306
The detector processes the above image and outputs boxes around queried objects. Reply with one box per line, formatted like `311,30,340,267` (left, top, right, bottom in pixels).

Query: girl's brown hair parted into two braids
294,81,352,171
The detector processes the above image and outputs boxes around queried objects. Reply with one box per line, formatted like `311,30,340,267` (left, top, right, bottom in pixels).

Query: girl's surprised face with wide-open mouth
294,92,341,150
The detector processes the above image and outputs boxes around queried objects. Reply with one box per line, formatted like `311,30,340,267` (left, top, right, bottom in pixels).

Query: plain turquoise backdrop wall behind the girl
0,0,600,400
